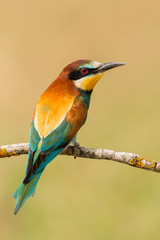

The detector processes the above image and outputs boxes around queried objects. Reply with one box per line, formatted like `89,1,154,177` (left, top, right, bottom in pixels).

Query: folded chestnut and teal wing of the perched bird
23,95,87,183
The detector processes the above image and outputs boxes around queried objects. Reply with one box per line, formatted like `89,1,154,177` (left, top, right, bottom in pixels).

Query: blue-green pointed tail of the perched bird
13,172,42,214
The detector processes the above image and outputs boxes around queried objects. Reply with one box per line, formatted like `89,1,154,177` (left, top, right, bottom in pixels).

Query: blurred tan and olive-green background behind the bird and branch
0,0,160,240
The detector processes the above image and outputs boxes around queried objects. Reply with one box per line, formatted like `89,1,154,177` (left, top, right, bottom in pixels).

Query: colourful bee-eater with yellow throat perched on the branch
13,60,125,214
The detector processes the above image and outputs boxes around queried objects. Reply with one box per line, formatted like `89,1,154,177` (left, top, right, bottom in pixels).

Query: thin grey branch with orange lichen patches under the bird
0,143,160,172
